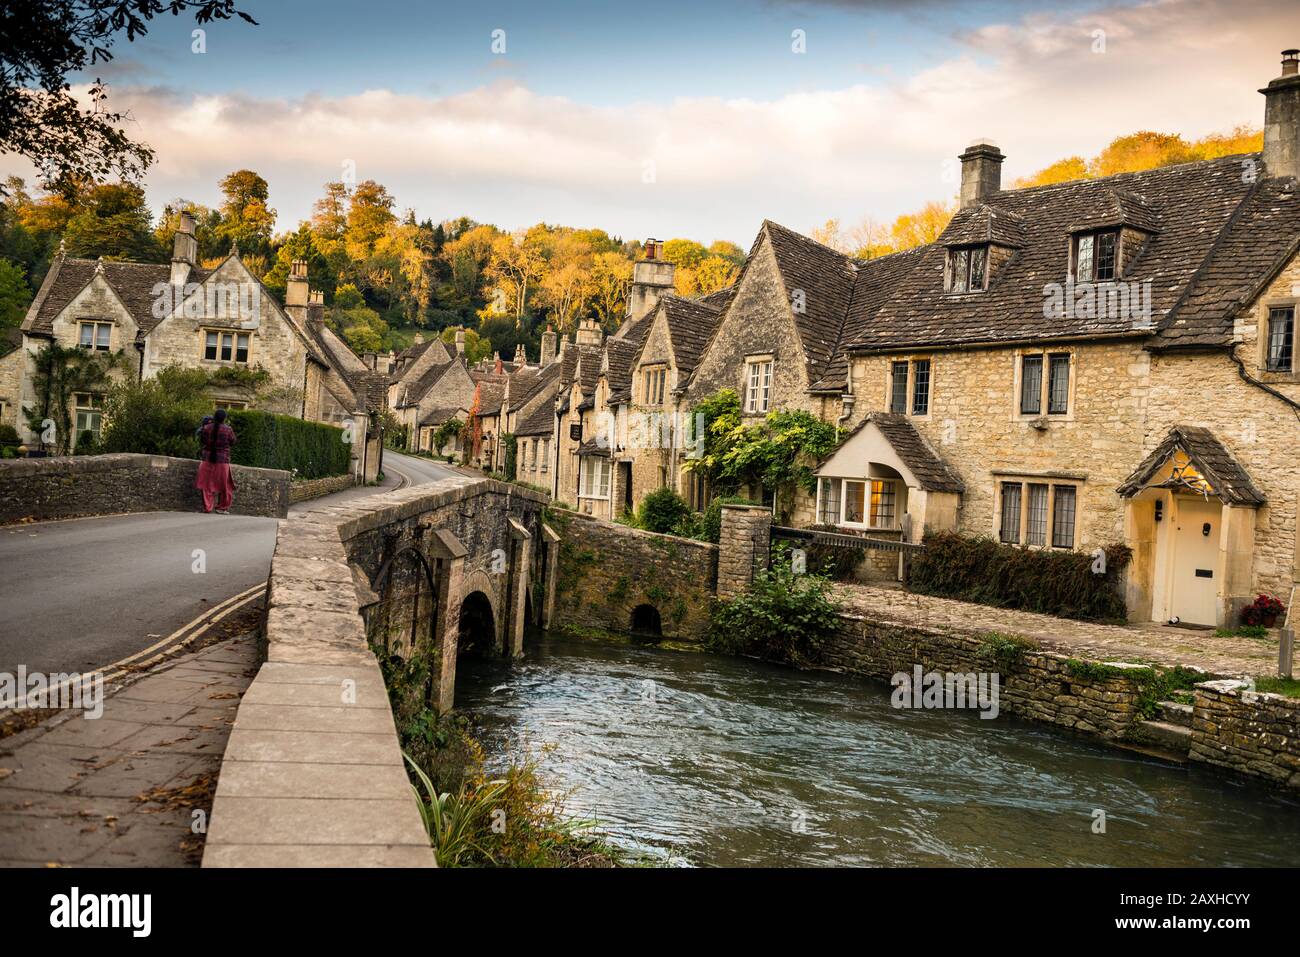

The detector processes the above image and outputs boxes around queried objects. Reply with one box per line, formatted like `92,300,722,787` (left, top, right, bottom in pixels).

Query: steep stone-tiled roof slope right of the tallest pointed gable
763,220,855,382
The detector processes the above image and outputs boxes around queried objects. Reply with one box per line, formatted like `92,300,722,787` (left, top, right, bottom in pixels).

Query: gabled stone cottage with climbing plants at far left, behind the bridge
15,213,384,477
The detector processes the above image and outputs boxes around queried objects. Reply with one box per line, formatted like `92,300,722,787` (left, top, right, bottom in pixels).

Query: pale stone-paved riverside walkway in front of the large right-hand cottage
836,585,1278,676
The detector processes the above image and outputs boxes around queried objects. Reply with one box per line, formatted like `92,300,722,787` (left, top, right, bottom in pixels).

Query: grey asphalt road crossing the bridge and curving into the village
0,451,465,674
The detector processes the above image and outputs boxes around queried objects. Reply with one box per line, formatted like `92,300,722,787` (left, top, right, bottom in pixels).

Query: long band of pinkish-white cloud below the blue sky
5,0,1300,244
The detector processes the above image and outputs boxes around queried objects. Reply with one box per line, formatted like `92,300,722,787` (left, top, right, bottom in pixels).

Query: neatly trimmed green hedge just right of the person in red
226,408,352,479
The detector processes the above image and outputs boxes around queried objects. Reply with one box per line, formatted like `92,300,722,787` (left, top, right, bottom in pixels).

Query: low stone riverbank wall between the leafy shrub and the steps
820,614,1147,739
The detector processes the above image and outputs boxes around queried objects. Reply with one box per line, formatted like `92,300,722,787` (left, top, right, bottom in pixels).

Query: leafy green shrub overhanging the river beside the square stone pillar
707,562,839,666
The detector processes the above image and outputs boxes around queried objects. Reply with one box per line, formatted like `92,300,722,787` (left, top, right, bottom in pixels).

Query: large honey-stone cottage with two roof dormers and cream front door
811,51,1300,624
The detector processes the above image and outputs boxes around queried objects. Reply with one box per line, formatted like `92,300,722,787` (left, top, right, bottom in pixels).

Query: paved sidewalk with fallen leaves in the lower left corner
0,633,257,867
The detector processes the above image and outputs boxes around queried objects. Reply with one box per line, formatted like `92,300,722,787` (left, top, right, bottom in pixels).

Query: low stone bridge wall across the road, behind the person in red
0,452,289,524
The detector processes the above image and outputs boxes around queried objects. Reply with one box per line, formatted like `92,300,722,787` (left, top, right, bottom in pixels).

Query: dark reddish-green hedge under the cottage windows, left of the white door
907,532,1132,622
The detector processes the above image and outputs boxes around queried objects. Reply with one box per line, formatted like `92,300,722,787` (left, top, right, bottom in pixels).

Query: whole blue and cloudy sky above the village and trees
0,0,1300,246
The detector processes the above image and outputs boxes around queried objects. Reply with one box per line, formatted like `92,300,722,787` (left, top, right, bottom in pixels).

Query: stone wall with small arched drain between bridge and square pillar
554,510,718,641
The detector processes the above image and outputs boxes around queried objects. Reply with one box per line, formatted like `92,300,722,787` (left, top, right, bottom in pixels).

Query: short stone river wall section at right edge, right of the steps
1188,680,1300,788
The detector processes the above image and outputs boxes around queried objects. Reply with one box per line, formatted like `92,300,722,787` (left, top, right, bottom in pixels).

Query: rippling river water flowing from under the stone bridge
456,636,1300,866
